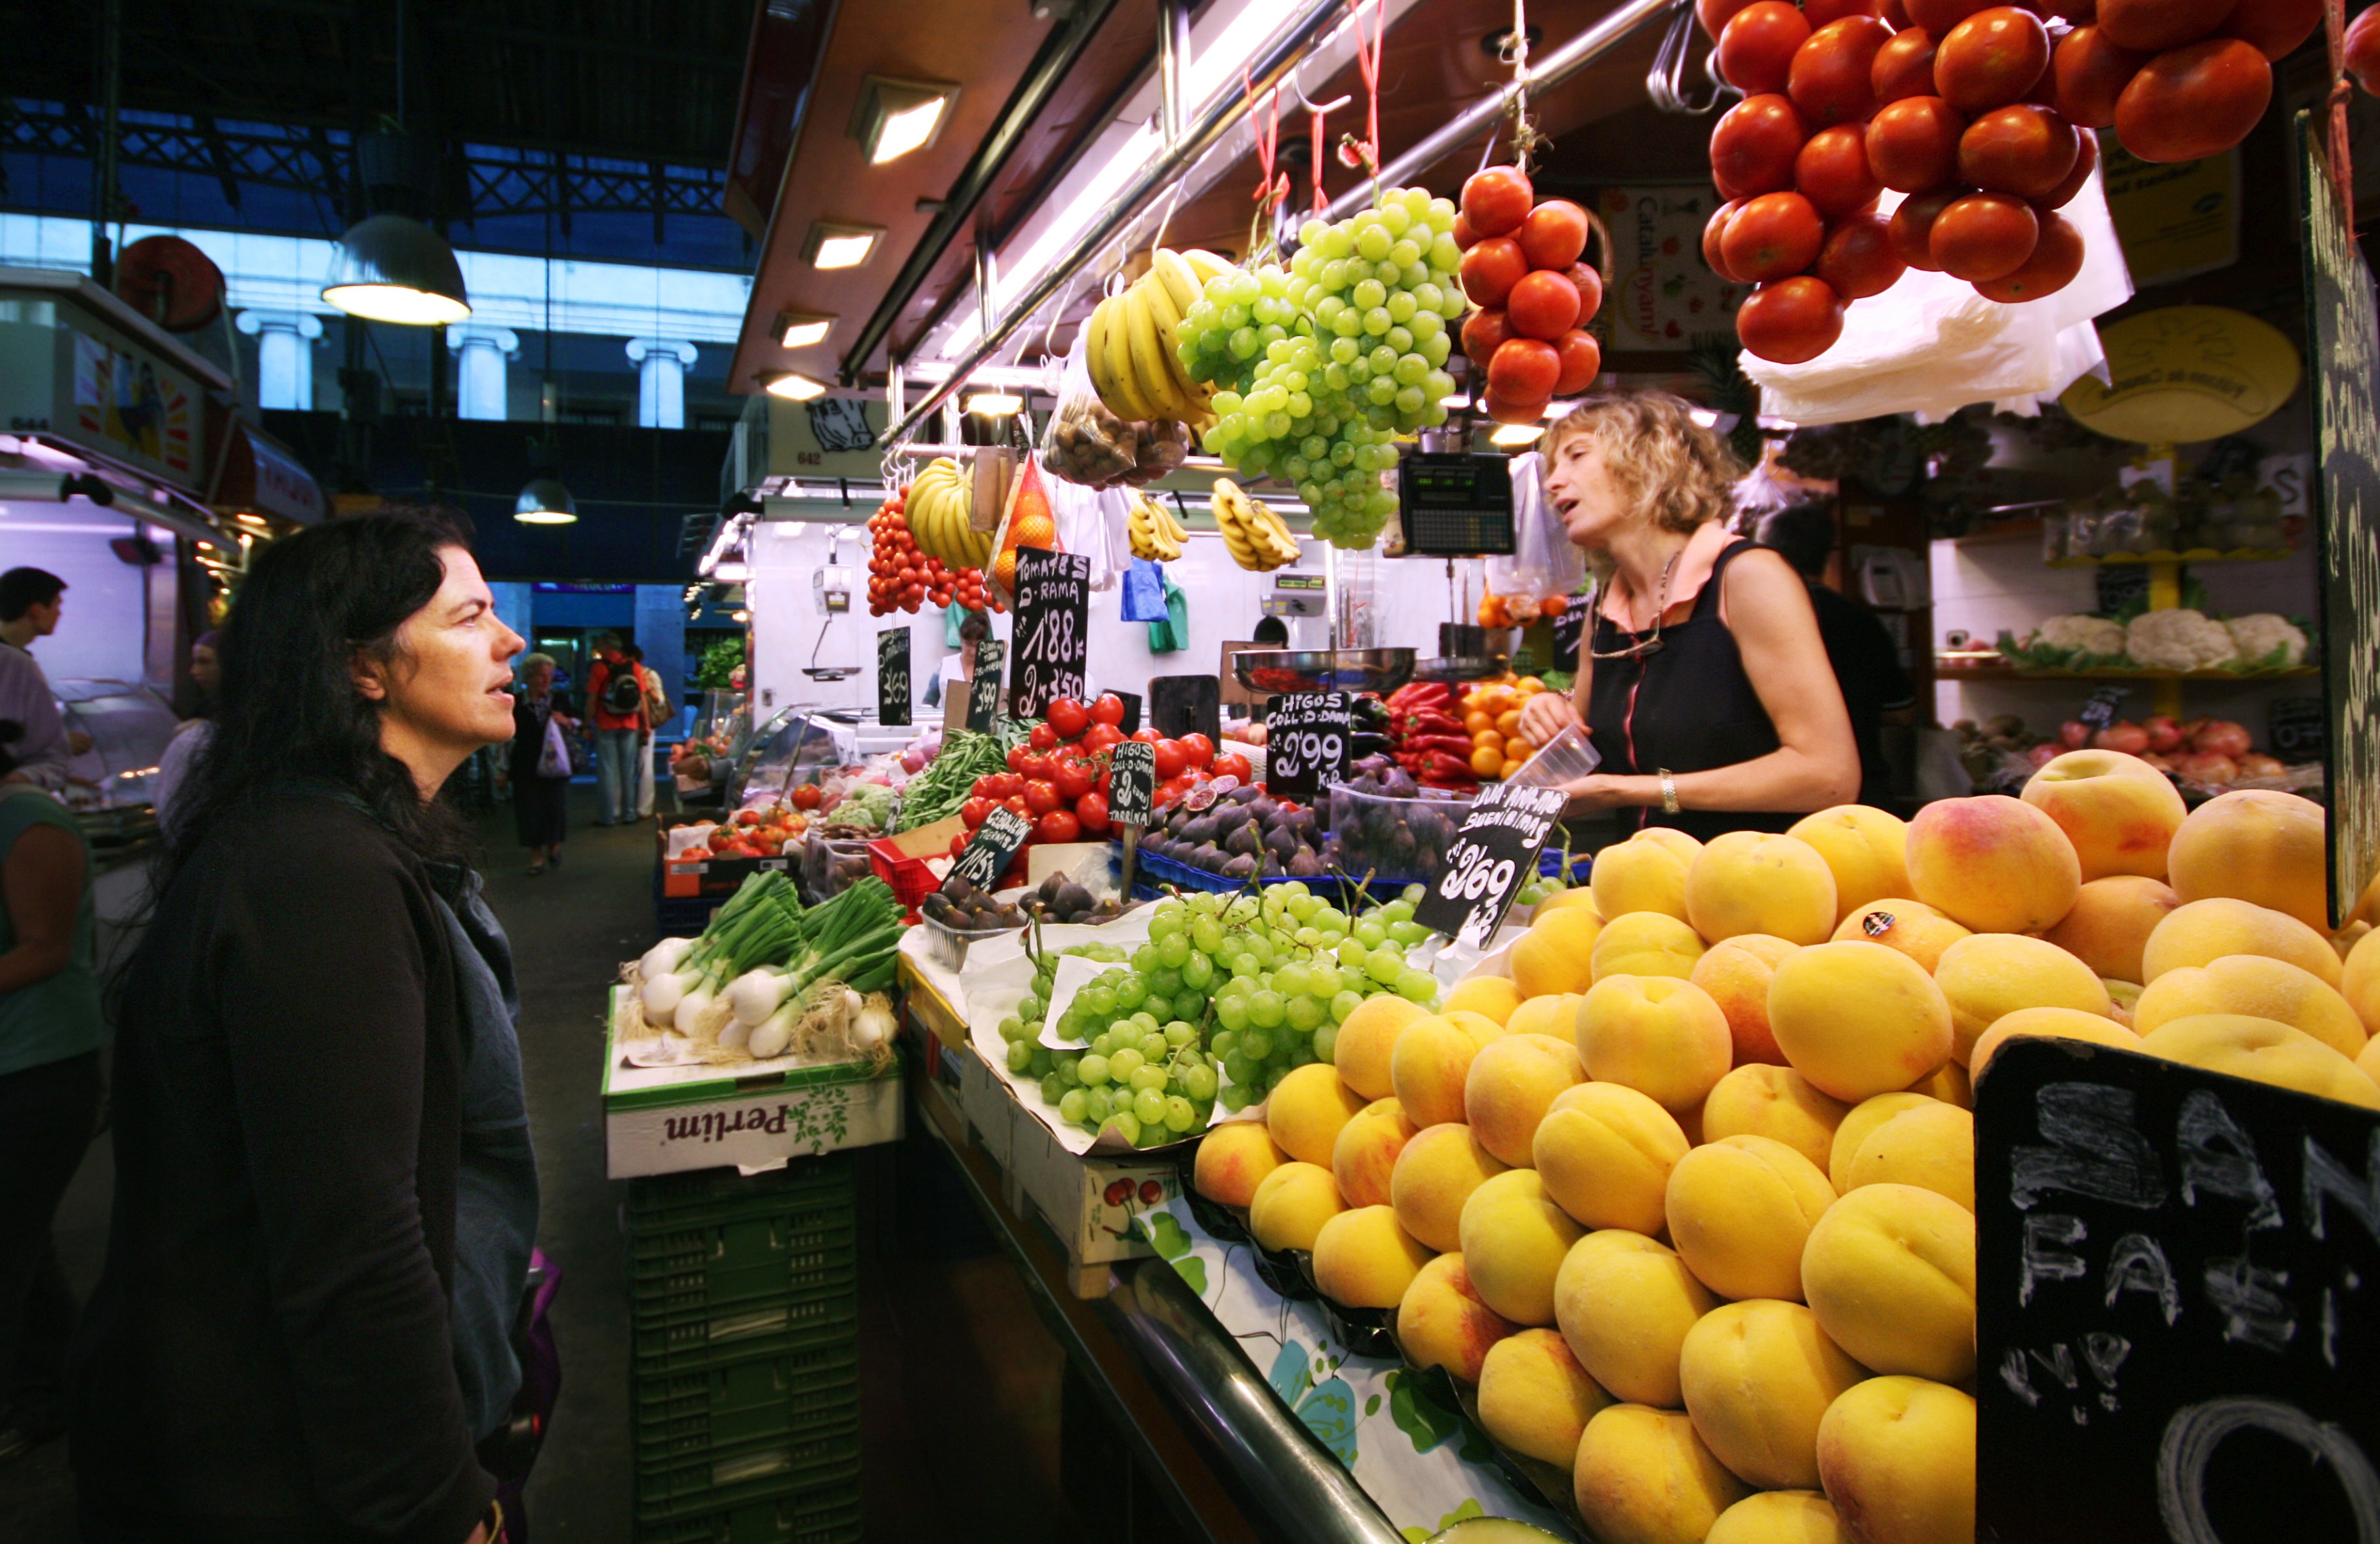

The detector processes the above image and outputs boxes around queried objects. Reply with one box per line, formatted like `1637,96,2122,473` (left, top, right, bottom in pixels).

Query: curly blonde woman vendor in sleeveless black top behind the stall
1521,392,1859,840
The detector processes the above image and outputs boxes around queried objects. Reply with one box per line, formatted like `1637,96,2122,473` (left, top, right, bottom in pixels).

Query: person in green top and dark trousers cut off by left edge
0,721,100,1463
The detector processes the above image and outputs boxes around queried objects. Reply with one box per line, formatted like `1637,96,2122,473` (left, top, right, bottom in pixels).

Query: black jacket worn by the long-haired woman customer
71,792,495,1544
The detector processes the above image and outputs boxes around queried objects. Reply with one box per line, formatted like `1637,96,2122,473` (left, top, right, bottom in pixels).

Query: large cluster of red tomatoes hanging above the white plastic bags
1697,0,2320,364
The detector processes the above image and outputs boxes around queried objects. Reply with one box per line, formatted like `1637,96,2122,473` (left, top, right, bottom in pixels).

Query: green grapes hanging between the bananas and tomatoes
1178,188,1468,552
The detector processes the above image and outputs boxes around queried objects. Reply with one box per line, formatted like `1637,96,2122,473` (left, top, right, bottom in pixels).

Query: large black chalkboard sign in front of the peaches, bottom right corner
1975,1040,2380,1544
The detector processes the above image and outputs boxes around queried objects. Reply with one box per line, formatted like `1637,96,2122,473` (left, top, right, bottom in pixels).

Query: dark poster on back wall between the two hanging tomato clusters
1594,183,1747,352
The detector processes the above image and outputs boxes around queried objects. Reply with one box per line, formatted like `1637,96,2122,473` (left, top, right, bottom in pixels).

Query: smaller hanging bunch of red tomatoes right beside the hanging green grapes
1454,167,1604,424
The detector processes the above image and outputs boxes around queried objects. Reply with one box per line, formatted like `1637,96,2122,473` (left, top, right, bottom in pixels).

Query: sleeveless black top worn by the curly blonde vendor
1588,540,1802,842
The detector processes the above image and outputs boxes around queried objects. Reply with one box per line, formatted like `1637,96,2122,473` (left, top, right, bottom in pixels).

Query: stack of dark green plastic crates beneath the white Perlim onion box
628,1154,859,1544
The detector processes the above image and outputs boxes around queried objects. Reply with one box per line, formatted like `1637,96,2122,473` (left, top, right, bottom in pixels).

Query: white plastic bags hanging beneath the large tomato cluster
1742,171,2133,424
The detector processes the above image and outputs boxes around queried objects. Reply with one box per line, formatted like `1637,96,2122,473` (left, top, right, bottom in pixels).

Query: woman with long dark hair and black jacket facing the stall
69,514,538,1544
